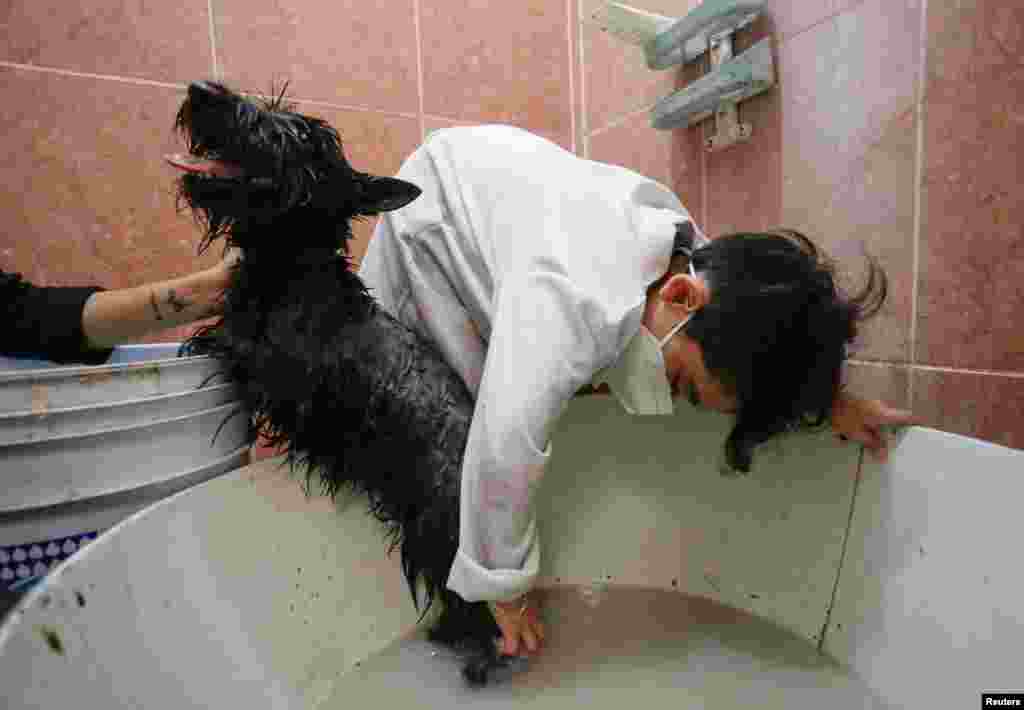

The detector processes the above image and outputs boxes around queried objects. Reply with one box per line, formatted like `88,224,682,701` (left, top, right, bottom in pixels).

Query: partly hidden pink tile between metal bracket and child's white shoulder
590,112,703,226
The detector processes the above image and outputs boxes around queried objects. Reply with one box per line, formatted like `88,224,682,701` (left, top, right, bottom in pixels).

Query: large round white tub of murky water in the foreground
0,396,1024,710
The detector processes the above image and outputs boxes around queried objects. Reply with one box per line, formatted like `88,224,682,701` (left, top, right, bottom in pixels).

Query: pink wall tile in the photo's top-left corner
0,0,212,82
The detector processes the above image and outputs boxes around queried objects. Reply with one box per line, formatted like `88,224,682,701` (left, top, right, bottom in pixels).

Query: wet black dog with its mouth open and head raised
172,82,504,684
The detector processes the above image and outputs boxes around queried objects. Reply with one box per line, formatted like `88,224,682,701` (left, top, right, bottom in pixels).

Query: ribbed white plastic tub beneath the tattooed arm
0,343,249,602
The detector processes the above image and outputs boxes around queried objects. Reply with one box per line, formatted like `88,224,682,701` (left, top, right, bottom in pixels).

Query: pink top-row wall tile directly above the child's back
420,0,572,150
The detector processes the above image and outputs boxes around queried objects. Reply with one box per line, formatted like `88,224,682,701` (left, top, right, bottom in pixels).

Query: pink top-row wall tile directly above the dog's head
214,0,419,114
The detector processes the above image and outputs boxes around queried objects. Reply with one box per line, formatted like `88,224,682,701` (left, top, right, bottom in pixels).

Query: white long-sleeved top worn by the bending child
359,125,703,601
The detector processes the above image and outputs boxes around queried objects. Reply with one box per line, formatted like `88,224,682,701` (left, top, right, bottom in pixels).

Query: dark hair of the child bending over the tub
670,224,888,472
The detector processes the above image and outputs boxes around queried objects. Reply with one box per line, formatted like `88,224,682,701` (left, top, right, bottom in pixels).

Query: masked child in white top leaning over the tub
359,126,912,655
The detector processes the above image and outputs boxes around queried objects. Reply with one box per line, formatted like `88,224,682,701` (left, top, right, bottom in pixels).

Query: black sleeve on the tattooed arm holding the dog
0,272,113,365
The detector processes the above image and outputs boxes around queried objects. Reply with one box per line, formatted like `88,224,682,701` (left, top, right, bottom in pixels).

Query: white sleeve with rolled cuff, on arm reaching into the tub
447,272,596,601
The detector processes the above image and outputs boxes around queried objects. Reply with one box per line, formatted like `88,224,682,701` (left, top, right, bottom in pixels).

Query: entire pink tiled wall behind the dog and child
0,0,1024,448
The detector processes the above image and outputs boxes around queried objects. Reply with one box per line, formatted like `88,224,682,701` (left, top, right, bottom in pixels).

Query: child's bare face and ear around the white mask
643,274,736,414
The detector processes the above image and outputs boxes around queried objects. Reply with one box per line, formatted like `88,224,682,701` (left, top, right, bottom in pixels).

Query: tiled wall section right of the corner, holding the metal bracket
580,0,1024,448
